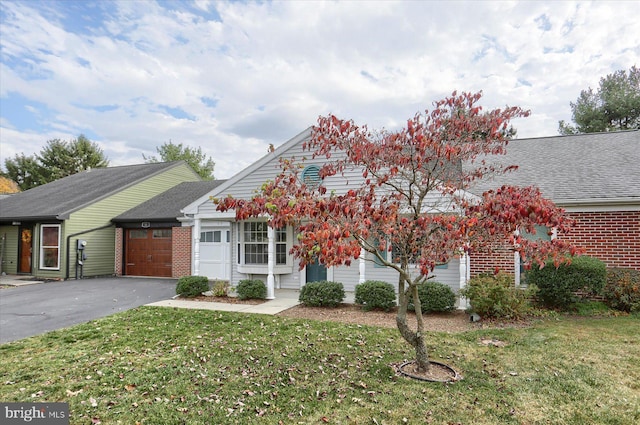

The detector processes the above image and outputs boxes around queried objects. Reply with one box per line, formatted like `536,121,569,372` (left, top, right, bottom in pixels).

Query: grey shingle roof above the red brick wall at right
472,130,640,205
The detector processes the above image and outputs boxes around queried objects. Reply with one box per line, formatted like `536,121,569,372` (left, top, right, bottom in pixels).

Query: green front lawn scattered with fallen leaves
0,307,640,425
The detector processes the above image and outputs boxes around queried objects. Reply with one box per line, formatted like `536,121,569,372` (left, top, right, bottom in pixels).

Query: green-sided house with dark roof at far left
0,161,201,279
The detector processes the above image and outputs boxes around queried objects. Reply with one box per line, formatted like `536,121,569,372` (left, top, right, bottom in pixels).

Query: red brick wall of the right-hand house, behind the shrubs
470,211,640,277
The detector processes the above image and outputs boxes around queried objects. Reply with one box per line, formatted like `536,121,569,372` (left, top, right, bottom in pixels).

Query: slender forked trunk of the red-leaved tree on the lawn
396,276,429,372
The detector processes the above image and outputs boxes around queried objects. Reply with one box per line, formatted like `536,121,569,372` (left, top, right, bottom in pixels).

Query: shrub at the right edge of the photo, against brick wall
602,267,640,313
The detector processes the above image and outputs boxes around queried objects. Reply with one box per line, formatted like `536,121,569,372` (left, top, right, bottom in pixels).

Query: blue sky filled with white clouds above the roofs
0,0,640,178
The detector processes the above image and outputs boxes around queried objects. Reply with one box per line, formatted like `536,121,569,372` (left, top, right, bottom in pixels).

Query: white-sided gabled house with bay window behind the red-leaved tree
180,128,467,298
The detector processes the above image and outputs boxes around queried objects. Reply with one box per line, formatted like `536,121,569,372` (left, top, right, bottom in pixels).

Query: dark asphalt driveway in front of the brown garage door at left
0,277,176,344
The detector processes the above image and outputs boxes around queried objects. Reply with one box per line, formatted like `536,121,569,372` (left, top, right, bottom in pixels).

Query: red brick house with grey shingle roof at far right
470,130,640,282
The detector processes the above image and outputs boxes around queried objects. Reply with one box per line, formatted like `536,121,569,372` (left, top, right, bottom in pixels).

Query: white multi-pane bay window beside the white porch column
240,221,287,265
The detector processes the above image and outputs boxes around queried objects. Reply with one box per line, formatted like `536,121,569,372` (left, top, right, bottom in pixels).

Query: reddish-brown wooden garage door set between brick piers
125,228,171,277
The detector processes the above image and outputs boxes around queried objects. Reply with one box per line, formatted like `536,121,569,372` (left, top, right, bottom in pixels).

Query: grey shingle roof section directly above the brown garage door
111,180,226,223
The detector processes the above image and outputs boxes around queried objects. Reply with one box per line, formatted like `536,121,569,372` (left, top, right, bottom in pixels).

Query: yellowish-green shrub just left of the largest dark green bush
460,273,537,319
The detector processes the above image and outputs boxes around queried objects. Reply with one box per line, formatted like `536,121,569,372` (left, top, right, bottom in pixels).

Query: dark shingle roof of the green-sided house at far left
0,161,194,221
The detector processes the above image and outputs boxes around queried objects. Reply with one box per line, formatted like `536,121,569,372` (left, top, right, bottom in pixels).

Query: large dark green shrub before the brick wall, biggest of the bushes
526,256,607,310
